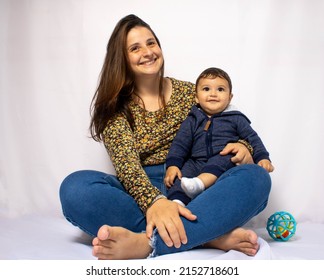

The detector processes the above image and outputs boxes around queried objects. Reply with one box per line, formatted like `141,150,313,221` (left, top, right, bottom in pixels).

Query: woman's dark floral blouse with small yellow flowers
103,78,195,213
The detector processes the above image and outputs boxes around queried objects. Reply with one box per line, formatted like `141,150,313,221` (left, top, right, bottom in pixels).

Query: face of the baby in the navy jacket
196,77,233,116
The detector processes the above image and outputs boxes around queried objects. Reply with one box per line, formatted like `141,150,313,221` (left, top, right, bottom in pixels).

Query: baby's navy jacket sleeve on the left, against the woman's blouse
166,115,193,169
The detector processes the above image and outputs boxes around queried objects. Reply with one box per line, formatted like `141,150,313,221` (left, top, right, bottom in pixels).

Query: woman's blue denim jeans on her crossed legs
60,164,271,256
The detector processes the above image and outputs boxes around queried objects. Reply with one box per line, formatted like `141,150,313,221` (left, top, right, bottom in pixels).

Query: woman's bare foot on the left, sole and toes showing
92,225,152,260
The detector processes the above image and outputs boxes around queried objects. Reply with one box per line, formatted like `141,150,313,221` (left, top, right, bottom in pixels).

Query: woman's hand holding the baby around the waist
220,143,253,165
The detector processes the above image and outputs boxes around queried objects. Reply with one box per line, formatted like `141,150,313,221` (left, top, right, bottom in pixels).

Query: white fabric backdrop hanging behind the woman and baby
0,0,324,226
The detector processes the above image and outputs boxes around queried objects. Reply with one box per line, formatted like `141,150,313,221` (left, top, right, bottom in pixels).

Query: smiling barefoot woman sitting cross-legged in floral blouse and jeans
60,15,271,259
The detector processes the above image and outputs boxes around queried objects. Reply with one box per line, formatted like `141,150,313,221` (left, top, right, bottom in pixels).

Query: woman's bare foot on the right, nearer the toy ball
204,228,259,256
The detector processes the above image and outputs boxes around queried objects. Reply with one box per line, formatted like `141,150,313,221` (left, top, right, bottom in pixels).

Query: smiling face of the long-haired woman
126,26,163,77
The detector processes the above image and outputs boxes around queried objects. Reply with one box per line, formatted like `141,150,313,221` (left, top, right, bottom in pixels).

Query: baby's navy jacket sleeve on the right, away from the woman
237,115,270,163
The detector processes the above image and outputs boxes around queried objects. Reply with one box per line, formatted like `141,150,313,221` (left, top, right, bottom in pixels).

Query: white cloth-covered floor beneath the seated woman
0,215,324,260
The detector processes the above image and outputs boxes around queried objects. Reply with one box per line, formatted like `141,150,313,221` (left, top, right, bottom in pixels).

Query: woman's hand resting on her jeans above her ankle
146,198,197,248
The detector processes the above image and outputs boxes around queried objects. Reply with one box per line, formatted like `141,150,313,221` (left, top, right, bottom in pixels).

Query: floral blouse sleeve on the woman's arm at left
103,112,162,213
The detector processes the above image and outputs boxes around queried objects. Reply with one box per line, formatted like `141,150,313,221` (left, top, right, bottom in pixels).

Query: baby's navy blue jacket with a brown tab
166,105,270,173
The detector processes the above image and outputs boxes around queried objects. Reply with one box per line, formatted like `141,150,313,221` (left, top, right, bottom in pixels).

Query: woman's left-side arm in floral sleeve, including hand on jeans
104,116,196,246
